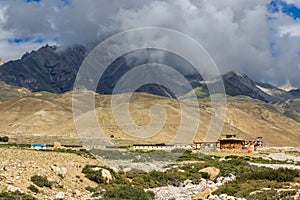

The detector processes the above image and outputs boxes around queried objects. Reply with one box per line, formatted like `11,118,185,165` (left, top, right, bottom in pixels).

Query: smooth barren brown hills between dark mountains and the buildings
0,88,300,146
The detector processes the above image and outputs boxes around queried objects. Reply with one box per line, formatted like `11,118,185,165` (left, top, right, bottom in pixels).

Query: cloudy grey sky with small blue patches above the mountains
0,0,300,87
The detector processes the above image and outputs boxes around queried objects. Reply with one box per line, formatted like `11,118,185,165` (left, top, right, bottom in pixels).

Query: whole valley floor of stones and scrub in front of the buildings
0,147,300,199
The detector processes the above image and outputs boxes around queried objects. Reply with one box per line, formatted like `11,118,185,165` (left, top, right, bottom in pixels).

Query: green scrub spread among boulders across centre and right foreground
82,151,300,199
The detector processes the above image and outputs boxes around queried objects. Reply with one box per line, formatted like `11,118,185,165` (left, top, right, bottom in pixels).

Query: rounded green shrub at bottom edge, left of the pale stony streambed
104,185,154,200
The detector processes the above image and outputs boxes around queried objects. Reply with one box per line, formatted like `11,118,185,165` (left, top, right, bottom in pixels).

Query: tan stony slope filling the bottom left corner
0,148,100,199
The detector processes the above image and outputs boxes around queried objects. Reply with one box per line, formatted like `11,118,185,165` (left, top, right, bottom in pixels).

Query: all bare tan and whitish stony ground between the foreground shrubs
0,147,300,200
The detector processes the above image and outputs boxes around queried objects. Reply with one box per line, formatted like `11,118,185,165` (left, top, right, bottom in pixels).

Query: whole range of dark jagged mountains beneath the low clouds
0,45,300,102
